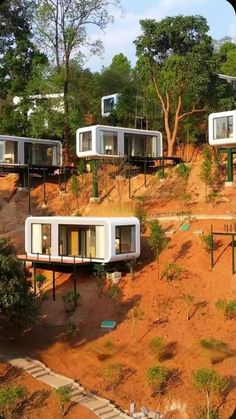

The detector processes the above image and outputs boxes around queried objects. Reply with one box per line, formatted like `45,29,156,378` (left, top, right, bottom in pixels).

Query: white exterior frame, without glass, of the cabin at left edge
0,135,62,166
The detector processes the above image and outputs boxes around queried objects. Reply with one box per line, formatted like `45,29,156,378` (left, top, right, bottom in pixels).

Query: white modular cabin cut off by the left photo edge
0,135,62,166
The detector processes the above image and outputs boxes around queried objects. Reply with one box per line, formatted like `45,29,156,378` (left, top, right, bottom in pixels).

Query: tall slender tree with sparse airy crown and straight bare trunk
33,0,119,163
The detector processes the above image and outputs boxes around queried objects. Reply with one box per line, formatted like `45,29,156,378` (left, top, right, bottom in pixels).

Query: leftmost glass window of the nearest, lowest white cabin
31,224,51,255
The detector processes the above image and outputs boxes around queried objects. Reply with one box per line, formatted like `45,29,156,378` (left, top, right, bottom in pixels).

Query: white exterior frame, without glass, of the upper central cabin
76,125,163,158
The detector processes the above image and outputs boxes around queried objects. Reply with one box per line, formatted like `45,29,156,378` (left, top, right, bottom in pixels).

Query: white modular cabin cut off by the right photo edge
208,110,236,147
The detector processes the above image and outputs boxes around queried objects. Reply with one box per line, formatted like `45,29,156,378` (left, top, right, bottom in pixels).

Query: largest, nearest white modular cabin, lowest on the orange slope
25,216,140,263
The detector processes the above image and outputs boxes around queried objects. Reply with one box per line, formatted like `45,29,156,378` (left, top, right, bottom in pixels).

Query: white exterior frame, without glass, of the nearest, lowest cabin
25,217,140,263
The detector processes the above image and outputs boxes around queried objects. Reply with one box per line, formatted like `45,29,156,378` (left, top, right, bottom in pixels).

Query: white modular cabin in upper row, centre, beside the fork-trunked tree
76,125,163,158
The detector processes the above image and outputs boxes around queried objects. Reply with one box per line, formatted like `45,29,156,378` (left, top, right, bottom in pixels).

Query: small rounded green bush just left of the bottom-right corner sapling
147,365,170,394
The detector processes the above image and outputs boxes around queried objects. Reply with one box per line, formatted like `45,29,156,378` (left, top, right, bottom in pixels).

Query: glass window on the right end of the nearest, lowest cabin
115,226,135,254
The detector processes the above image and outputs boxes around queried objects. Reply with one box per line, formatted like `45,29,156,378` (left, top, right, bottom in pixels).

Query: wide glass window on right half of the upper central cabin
124,133,157,157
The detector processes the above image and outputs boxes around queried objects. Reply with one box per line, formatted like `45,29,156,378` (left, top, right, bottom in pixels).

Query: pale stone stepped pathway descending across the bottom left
0,352,130,419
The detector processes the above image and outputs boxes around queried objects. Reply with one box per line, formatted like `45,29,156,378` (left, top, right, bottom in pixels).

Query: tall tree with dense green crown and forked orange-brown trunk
135,15,216,156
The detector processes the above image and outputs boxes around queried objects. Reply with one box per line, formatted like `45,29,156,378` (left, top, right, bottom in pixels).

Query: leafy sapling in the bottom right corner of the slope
193,368,228,419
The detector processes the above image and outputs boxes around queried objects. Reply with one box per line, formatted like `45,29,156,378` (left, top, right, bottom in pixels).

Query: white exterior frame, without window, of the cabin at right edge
208,110,236,147
